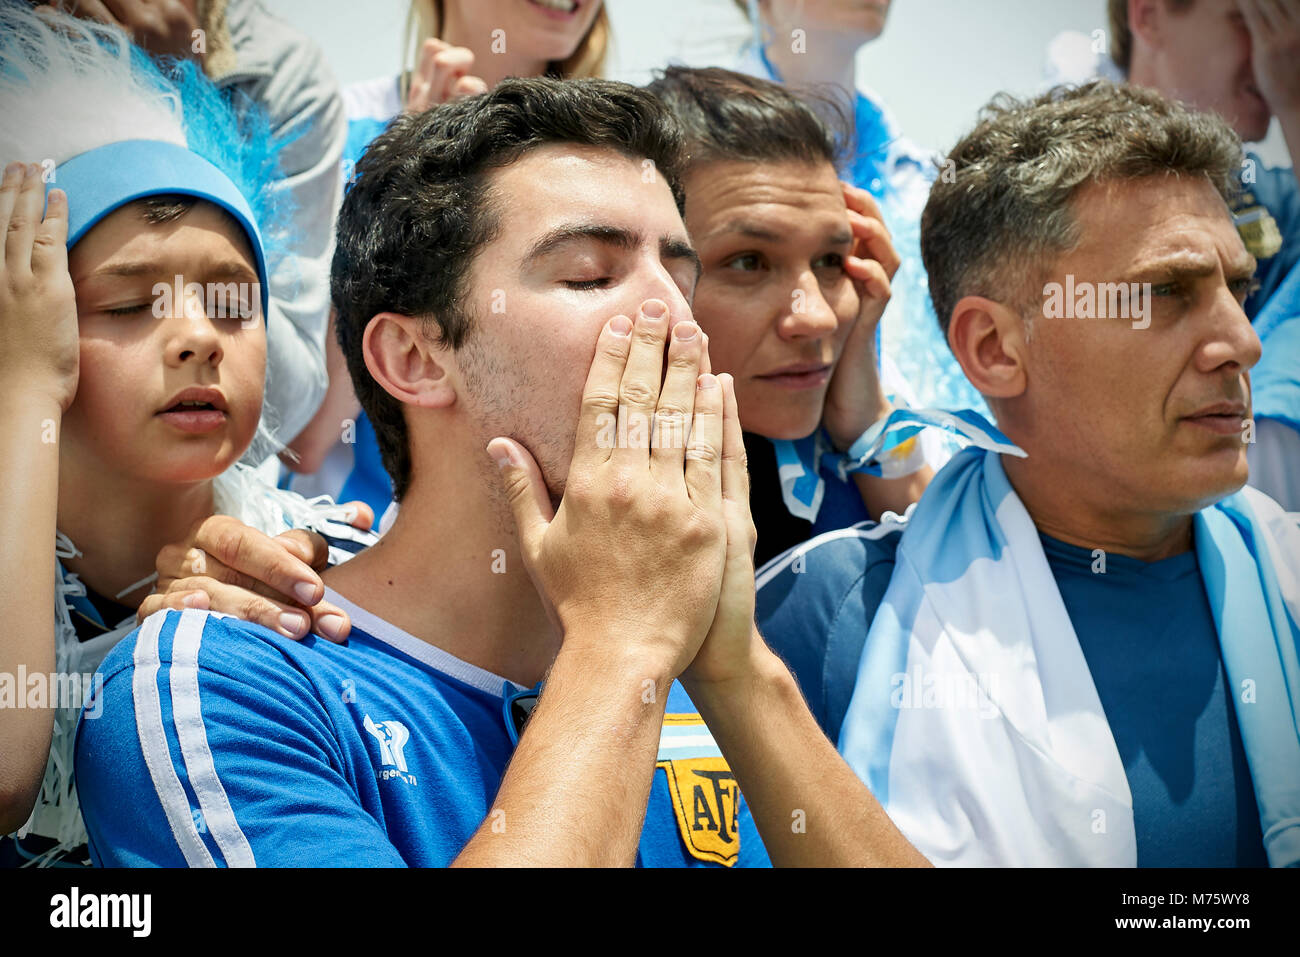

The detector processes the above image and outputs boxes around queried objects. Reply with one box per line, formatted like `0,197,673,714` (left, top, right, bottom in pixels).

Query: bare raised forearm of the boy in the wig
0,384,62,833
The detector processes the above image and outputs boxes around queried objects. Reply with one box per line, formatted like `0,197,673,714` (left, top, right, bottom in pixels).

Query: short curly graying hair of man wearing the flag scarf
920,81,1242,335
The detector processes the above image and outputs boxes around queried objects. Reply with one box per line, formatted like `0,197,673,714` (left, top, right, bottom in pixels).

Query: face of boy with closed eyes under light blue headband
61,202,267,482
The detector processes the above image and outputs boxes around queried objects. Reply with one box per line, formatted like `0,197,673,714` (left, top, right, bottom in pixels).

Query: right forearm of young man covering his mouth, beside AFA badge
686,629,927,867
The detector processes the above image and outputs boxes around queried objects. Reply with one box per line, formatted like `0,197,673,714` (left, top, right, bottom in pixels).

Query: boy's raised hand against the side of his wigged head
0,163,79,412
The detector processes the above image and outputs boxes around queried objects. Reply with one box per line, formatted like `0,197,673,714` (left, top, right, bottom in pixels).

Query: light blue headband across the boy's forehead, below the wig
47,139,270,321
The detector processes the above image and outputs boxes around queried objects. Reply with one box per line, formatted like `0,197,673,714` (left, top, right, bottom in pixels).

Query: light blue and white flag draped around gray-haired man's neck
840,426,1300,867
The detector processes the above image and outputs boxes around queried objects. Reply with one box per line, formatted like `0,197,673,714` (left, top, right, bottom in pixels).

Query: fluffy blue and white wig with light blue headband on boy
0,0,287,272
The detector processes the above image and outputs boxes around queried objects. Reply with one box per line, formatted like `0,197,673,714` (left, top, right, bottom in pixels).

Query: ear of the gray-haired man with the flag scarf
948,295,1027,399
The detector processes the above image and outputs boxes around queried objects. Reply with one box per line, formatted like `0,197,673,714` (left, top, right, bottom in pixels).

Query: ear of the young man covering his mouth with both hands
361,312,456,408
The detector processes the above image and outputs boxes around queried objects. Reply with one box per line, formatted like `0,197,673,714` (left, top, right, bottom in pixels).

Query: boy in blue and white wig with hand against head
0,4,367,862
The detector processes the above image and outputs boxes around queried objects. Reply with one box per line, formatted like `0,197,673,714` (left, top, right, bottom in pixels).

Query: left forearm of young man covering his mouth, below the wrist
454,635,672,867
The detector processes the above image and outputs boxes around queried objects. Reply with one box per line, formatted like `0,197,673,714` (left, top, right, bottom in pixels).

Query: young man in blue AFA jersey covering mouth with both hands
77,78,924,866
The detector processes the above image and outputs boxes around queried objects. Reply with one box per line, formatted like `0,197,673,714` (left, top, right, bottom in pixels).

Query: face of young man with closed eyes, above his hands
458,144,698,498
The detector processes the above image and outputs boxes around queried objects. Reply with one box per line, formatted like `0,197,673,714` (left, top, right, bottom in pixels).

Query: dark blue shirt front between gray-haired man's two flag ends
1039,536,1269,867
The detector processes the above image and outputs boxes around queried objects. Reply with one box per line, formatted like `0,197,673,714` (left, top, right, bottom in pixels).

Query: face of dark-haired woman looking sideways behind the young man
686,161,861,438
